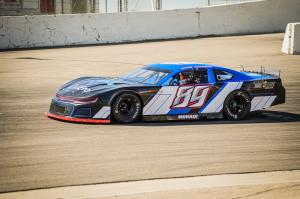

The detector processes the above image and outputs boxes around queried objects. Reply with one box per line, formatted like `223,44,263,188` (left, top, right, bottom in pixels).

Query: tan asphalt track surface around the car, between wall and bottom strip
0,34,300,192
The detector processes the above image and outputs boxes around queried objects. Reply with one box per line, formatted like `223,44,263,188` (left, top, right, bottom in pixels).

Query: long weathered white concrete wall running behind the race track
0,0,300,49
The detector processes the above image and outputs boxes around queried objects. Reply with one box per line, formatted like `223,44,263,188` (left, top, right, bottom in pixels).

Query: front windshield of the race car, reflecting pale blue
122,68,169,84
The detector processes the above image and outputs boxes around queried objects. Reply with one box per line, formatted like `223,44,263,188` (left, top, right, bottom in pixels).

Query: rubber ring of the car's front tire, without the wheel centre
112,92,142,124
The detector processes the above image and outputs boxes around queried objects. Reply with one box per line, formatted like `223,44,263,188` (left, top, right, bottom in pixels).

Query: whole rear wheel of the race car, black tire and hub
223,90,251,120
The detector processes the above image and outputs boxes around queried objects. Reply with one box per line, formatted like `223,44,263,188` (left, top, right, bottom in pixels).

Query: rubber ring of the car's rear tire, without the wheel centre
223,90,251,120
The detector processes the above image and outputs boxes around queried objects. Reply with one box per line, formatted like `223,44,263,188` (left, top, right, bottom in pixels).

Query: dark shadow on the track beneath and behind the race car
121,110,300,127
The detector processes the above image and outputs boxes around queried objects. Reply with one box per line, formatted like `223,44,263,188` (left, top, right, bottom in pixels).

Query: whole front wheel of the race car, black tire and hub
112,92,142,124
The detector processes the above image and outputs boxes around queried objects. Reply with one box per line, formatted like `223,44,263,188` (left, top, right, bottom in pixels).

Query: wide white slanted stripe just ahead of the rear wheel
201,82,243,113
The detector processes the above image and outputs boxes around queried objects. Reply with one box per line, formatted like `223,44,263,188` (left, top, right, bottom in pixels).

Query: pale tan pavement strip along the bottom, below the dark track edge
0,170,300,199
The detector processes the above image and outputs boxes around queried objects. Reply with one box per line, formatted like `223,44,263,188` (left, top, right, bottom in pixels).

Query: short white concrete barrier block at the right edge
281,23,300,54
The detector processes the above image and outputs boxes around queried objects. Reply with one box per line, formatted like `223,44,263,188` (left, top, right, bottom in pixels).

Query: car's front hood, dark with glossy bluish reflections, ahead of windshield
57,77,136,97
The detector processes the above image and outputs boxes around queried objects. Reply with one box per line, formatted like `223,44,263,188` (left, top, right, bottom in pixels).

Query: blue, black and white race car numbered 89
46,63,285,123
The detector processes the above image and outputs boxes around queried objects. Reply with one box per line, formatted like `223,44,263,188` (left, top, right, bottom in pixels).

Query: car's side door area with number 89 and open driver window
143,69,213,116
